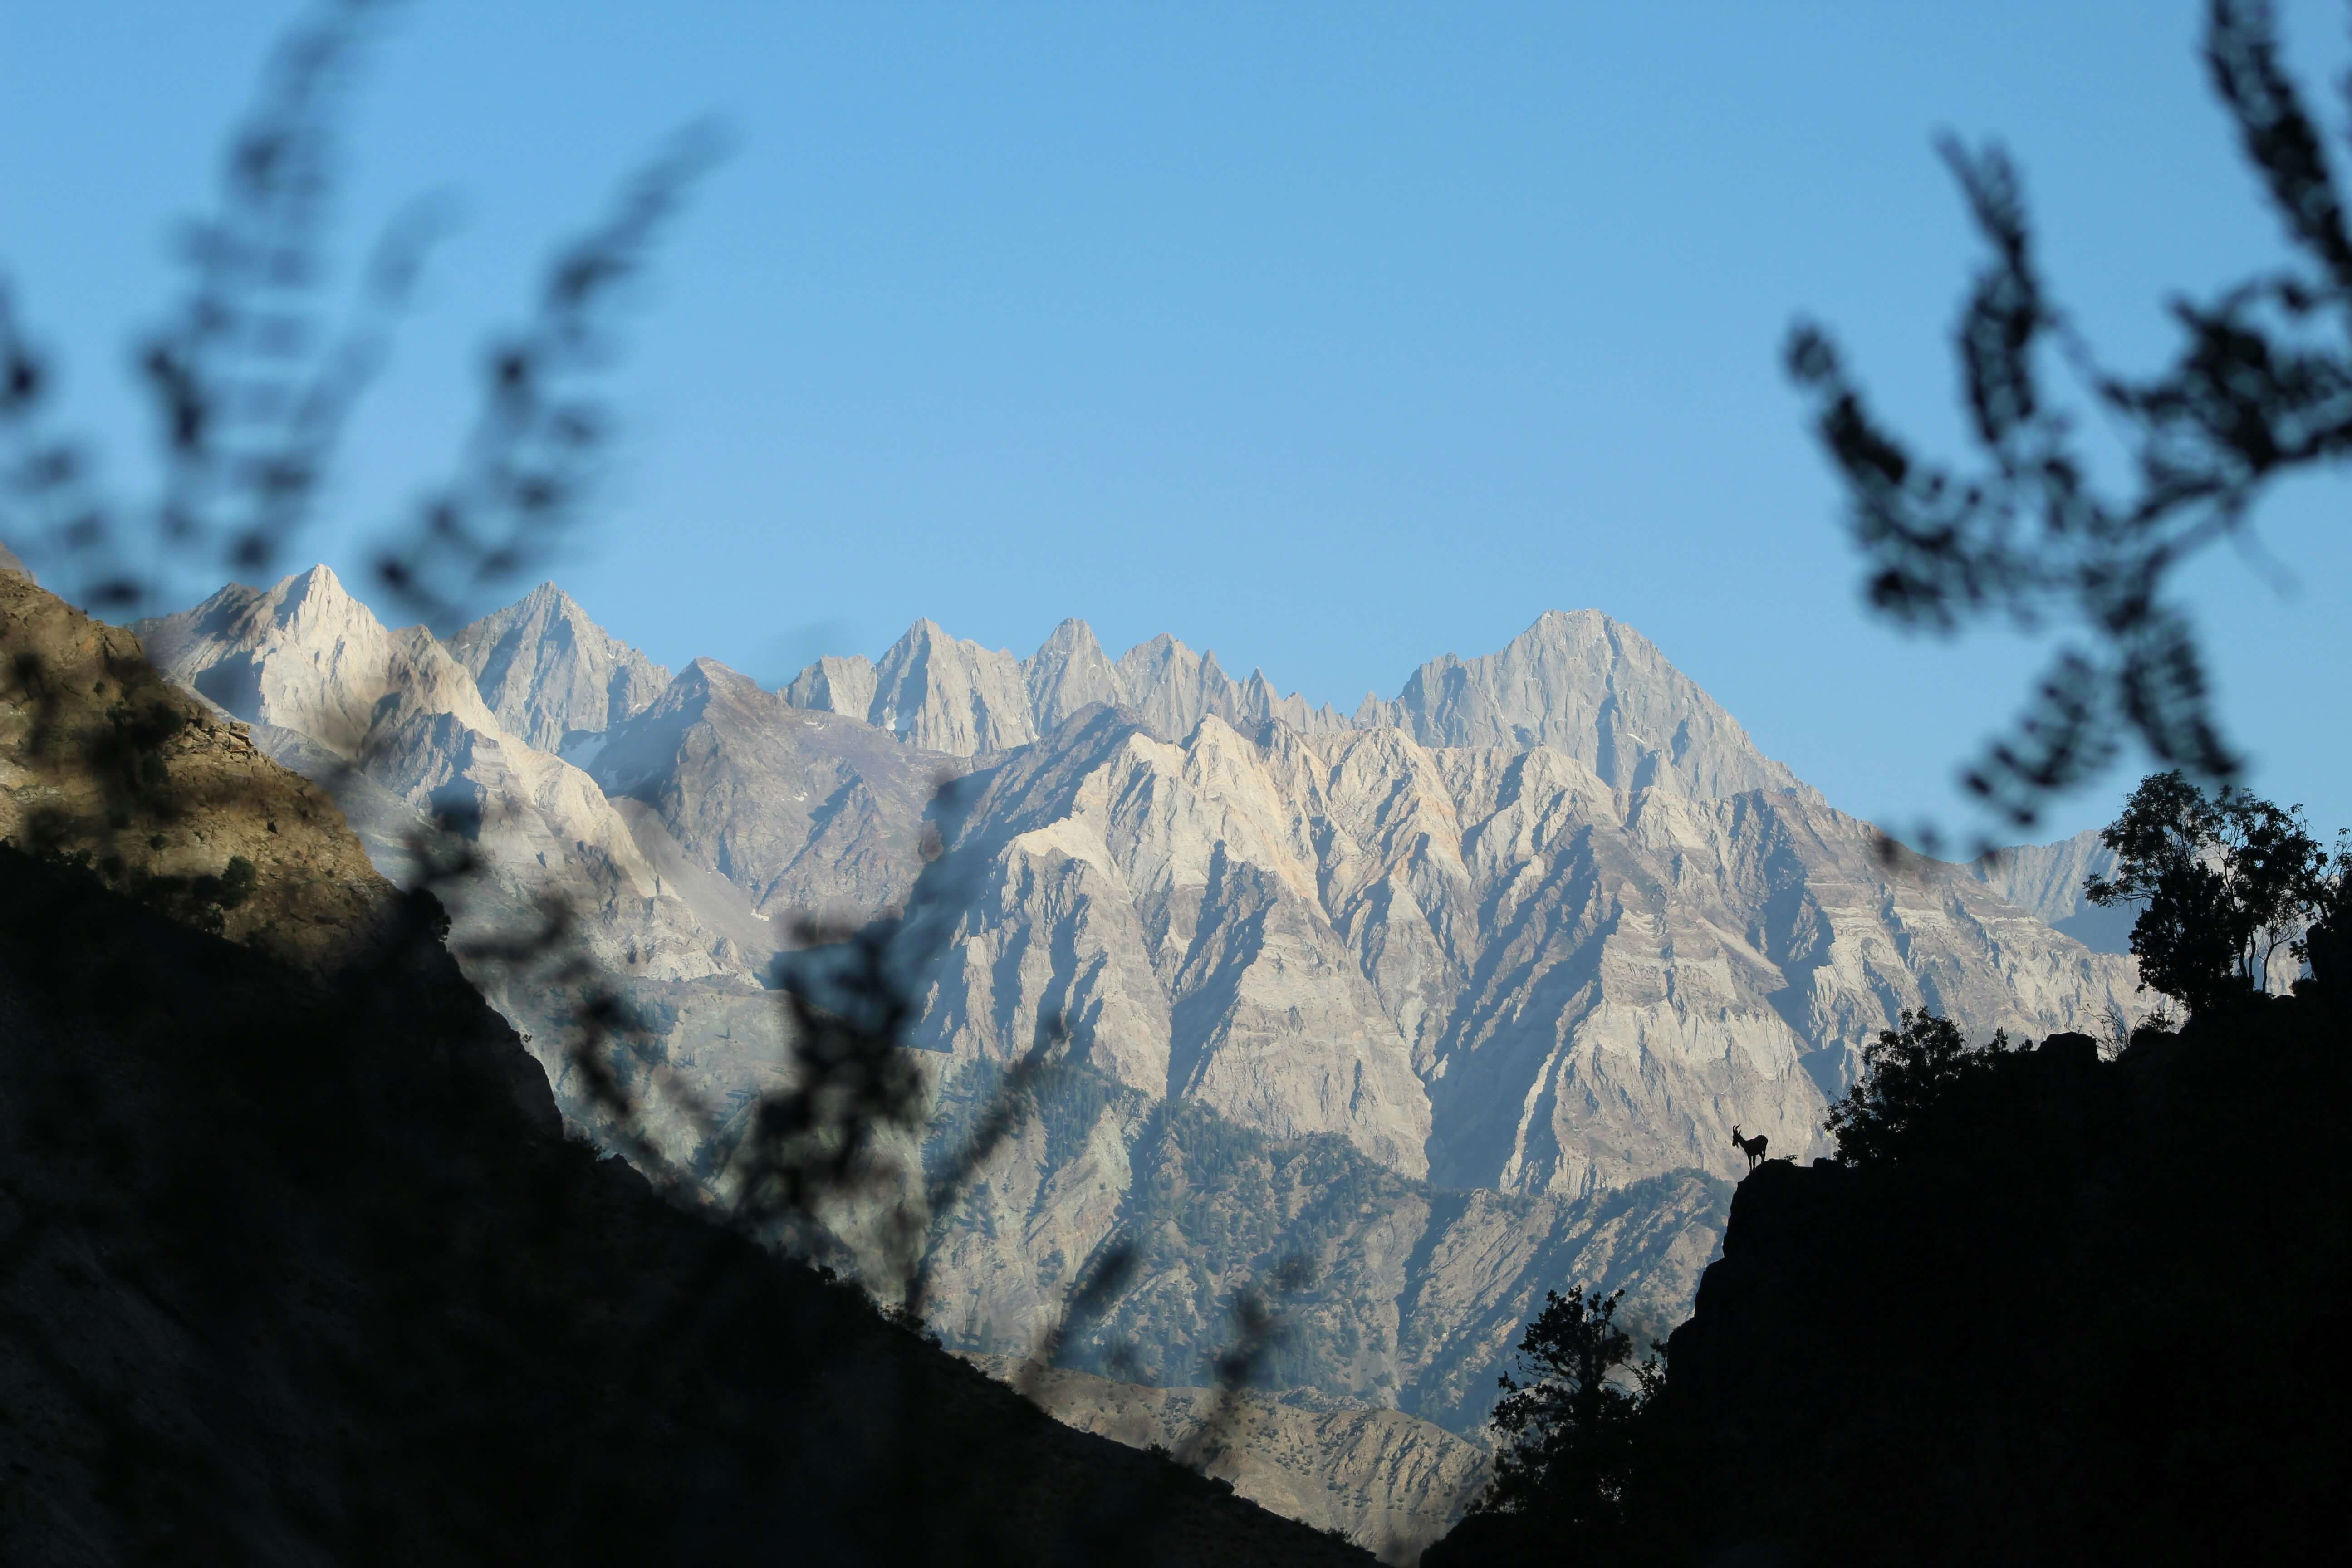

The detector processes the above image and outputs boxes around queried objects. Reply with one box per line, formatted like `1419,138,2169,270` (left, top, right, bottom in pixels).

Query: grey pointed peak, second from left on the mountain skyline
447,583,670,752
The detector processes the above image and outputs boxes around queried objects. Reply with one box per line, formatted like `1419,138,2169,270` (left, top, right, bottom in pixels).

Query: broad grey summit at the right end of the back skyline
1355,609,1818,799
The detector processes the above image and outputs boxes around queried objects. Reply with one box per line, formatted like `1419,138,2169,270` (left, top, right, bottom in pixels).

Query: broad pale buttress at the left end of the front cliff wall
924,710,1430,1176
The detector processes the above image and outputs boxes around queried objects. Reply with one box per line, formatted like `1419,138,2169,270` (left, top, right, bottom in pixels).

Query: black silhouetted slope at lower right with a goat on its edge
1430,1006,2352,1566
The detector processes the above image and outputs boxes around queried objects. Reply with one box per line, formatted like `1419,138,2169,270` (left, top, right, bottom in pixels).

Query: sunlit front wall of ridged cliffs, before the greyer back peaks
924,710,2133,1194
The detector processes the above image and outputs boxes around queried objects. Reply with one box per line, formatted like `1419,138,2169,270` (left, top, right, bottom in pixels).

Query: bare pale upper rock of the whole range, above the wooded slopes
141,569,2138,1196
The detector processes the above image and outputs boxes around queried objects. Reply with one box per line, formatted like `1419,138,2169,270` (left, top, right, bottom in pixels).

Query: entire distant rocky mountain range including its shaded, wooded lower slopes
124,569,2138,1542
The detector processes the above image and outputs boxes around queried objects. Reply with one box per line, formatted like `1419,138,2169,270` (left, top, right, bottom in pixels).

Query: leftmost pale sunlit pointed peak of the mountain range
132,567,499,757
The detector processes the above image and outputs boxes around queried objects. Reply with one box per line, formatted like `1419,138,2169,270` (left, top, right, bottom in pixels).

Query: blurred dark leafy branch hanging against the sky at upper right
1788,0,2352,825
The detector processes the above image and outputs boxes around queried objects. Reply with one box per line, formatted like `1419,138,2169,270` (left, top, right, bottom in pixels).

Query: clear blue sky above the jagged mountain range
0,0,2352,851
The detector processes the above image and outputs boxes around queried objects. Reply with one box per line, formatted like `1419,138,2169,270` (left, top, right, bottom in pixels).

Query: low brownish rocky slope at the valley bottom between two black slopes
974,1357,1489,1563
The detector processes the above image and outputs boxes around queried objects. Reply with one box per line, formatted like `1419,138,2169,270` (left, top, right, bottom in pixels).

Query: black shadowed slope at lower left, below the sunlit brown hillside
0,851,1364,1563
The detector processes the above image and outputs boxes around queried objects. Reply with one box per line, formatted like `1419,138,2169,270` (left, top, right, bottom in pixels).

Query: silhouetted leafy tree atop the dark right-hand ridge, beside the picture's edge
2082,769,2333,1013
